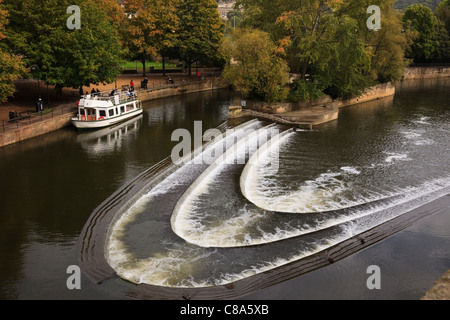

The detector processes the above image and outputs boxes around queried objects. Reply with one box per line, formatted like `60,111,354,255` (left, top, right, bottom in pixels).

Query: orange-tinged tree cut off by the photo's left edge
0,0,27,102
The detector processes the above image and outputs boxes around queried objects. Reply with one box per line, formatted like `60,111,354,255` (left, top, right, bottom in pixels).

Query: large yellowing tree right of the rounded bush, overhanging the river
237,0,409,99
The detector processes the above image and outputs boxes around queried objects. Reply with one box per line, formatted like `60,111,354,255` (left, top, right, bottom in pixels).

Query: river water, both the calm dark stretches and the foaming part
0,79,450,299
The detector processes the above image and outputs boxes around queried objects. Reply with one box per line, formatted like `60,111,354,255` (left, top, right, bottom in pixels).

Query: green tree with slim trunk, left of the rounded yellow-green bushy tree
176,0,224,75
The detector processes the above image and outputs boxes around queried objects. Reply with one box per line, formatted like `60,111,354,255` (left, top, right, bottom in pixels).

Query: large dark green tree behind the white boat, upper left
4,0,123,92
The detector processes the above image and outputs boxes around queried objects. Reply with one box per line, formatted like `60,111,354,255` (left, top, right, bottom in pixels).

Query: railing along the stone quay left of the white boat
0,105,77,133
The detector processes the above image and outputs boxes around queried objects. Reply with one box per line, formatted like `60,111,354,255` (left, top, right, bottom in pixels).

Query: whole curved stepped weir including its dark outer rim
80,99,450,299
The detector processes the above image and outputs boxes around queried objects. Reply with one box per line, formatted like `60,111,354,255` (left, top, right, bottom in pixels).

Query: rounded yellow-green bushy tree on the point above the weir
222,29,289,102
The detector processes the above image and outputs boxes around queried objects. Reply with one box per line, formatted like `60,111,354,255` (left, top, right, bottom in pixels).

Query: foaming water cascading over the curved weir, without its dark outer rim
106,89,450,288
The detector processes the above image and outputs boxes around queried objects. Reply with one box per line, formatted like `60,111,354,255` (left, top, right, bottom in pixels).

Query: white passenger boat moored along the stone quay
72,92,143,129
